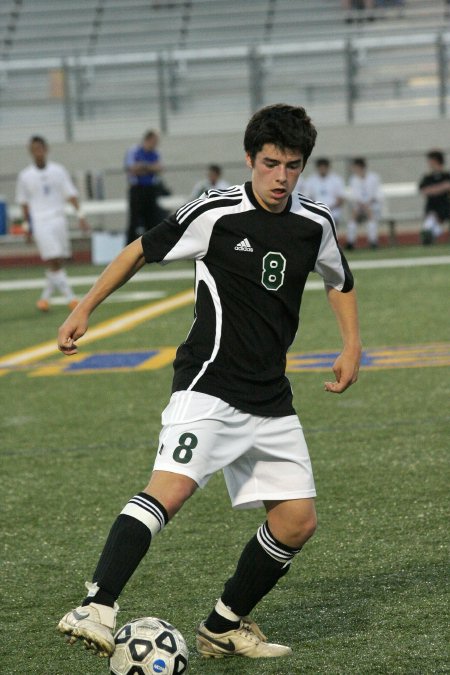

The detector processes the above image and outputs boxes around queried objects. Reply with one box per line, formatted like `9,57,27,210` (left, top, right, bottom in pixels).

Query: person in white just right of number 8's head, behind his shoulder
304,157,345,227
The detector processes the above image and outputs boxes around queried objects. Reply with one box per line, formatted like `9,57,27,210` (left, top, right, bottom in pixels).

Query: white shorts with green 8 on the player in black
154,391,316,508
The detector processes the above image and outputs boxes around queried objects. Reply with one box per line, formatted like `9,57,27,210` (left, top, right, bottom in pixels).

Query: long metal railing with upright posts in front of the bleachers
0,31,450,142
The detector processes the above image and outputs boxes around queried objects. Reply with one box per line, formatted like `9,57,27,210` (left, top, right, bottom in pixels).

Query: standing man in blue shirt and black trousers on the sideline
125,131,166,244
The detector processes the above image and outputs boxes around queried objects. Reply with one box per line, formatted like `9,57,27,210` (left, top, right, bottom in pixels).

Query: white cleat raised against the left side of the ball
58,602,119,656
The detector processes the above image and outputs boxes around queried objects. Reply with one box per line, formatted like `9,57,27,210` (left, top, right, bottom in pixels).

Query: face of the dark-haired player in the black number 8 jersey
246,143,304,213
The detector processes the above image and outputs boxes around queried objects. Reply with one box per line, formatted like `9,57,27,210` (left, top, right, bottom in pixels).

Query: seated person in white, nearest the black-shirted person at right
346,157,383,251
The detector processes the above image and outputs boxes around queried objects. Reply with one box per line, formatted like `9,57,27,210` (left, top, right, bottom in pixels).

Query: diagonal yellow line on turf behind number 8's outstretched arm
0,289,194,375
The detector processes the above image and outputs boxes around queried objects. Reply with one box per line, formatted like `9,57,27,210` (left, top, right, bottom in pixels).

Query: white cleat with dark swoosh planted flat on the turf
197,618,292,659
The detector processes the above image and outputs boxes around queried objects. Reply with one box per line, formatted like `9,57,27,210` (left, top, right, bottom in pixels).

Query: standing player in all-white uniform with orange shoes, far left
16,136,89,312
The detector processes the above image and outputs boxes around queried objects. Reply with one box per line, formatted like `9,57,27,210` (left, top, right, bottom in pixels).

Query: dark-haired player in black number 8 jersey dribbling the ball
58,104,361,658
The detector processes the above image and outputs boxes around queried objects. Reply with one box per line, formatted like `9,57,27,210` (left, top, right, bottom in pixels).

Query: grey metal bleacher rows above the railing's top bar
0,0,448,59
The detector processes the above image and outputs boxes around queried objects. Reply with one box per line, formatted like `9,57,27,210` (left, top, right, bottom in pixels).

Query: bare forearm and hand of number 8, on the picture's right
325,286,362,394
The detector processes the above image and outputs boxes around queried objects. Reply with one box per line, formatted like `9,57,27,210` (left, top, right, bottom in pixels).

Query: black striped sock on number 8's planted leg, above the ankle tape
220,523,300,616
